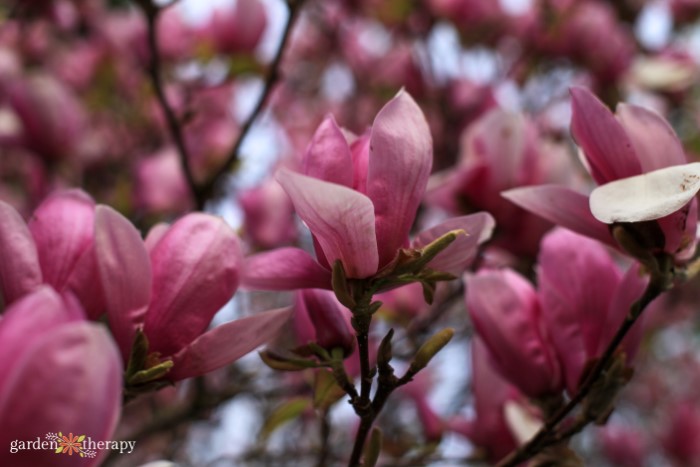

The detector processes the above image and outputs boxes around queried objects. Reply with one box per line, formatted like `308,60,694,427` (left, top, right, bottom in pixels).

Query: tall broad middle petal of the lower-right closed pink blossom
538,228,621,394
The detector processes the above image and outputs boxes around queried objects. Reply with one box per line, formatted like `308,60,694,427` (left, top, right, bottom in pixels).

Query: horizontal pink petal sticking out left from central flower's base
241,247,331,290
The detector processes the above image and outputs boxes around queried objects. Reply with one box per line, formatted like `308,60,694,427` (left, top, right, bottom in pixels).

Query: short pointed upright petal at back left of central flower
303,115,353,187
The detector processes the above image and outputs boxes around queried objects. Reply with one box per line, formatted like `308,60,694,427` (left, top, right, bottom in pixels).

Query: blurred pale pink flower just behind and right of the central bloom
427,109,574,256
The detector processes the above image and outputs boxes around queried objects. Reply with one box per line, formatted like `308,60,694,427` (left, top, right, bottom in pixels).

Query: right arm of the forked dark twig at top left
200,0,304,202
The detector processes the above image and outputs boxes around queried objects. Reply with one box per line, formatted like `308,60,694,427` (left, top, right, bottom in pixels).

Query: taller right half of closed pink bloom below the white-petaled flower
537,228,647,394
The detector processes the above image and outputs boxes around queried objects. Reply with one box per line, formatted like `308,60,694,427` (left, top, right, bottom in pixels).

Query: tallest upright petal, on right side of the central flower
366,91,433,266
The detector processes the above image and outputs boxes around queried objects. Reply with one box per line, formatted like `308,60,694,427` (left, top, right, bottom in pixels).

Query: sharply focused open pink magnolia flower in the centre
244,92,493,290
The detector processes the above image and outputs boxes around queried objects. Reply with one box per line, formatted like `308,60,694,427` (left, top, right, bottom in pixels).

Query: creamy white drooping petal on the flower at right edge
590,162,700,224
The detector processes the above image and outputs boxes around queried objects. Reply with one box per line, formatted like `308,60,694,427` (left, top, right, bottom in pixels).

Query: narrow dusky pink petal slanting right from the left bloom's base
167,308,292,381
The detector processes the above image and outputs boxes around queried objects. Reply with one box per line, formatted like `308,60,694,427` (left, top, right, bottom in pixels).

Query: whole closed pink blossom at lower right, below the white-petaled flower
466,229,647,397
